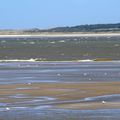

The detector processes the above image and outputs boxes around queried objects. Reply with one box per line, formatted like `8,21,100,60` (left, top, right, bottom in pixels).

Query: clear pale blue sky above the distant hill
0,0,120,29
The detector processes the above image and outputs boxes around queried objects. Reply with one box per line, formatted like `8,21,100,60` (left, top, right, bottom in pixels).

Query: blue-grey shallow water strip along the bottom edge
0,108,120,120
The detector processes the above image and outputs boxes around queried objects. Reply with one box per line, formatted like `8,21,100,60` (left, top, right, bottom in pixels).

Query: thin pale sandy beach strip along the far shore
0,33,120,38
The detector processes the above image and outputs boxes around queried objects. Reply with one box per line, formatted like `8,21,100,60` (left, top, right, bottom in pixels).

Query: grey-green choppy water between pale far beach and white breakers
0,36,120,61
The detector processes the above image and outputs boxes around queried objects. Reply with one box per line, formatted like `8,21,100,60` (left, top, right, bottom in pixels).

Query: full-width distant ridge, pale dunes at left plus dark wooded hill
0,23,120,35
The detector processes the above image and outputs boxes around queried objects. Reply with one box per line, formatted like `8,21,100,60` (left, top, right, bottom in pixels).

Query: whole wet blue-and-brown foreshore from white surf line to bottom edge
0,61,120,120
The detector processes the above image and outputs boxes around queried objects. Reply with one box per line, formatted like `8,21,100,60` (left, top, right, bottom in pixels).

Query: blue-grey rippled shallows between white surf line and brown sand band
0,62,120,84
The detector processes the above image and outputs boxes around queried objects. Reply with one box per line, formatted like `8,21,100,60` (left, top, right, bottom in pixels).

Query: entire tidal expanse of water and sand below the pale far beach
0,36,120,120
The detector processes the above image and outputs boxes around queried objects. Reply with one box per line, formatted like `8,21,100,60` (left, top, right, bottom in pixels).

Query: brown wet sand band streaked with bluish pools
0,82,120,109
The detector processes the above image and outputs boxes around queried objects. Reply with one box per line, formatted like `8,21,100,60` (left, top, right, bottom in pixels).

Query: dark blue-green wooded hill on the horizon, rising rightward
25,23,120,32
